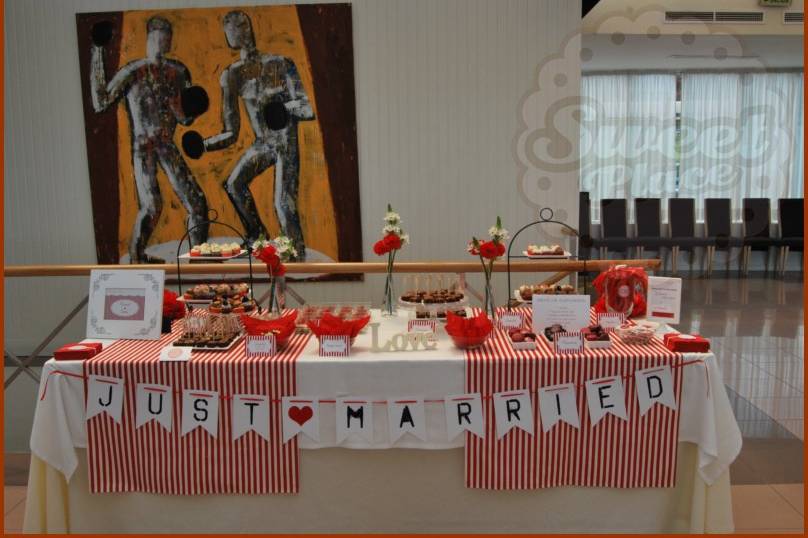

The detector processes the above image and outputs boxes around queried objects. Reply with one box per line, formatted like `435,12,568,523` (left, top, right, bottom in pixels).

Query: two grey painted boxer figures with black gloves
90,11,314,263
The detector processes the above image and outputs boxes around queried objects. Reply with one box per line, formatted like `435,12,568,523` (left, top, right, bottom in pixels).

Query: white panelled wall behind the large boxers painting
4,0,581,449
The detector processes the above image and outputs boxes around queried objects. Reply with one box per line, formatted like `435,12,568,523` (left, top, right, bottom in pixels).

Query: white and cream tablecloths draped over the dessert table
24,311,741,533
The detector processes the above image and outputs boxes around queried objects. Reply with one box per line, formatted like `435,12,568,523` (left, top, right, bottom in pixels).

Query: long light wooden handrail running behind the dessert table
3,259,661,278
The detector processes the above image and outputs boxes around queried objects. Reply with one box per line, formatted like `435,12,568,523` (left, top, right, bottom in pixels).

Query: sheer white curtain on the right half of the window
679,73,803,220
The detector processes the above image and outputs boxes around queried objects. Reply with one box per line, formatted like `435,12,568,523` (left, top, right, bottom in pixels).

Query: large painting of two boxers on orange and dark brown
76,4,362,272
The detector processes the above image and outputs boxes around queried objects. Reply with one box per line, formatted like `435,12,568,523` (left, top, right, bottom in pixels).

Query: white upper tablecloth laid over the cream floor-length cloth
26,317,741,530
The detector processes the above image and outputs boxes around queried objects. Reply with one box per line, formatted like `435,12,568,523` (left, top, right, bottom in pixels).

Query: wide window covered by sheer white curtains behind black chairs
580,72,803,220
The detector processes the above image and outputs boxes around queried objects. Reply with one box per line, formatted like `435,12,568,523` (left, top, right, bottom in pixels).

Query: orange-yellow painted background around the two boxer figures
118,6,338,260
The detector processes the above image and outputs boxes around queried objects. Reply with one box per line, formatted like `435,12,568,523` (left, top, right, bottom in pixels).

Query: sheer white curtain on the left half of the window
580,74,676,220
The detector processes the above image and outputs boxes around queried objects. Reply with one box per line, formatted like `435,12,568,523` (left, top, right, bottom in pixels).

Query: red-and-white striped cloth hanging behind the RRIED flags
465,309,682,490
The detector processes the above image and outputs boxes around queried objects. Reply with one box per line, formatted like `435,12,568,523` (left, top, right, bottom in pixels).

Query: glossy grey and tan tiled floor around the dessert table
4,275,805,534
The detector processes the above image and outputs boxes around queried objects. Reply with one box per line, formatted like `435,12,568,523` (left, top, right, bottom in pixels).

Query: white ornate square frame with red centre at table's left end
87,269,166,340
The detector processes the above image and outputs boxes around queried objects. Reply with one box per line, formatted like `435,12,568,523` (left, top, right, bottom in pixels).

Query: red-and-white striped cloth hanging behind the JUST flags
84,318,309,495
